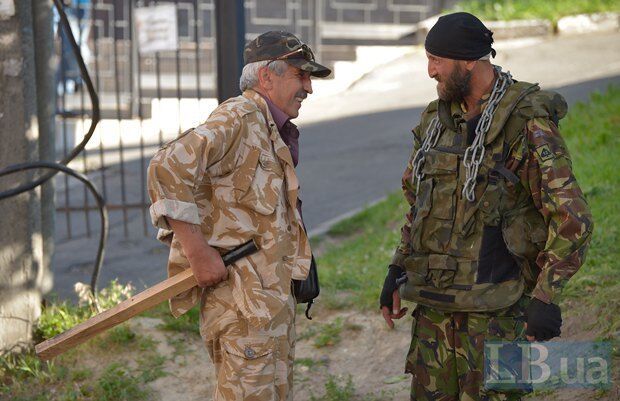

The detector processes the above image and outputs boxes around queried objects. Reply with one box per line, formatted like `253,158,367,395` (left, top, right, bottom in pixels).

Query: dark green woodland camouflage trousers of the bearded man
405,297,529,401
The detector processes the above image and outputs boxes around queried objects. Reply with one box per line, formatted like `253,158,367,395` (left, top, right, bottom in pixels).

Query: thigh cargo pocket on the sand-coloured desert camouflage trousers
218,336,276,399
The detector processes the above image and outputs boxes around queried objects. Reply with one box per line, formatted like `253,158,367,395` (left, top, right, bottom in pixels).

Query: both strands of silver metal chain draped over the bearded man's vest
412,66,513,202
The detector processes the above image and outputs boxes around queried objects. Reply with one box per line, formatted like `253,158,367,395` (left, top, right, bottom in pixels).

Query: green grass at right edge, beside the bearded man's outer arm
560,86,620,336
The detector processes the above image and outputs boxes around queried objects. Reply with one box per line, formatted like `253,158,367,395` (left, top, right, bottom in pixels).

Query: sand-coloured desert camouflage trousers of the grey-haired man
201,282,295,401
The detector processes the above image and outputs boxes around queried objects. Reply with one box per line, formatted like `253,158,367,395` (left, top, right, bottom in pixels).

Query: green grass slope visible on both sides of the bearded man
318,86,620,334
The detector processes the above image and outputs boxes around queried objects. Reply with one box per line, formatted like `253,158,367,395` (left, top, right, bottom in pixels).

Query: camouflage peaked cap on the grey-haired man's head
243,31,332,78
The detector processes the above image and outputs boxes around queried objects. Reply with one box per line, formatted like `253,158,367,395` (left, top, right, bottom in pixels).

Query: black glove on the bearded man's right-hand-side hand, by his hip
525,298,562,341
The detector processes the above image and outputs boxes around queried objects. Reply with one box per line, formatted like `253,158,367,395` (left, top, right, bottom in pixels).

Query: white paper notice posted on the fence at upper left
134,4,179,53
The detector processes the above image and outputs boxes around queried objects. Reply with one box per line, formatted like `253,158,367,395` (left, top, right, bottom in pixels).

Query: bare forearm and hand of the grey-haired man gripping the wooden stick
168,219,228,287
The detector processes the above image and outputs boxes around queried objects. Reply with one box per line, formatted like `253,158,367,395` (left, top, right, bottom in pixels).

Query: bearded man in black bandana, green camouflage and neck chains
380,13,593,401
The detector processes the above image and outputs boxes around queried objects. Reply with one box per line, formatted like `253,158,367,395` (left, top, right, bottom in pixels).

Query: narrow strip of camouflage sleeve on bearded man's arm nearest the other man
390,125,420,267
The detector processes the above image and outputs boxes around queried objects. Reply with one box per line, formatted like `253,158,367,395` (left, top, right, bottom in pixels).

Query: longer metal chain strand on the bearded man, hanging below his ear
463,66,513,202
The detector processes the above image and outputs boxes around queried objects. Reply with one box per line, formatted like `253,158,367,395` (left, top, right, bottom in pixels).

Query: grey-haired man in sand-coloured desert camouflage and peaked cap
148,32,331,401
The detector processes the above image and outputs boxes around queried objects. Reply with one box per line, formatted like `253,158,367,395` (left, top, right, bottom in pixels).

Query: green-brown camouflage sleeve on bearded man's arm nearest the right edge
522,118,594,303
